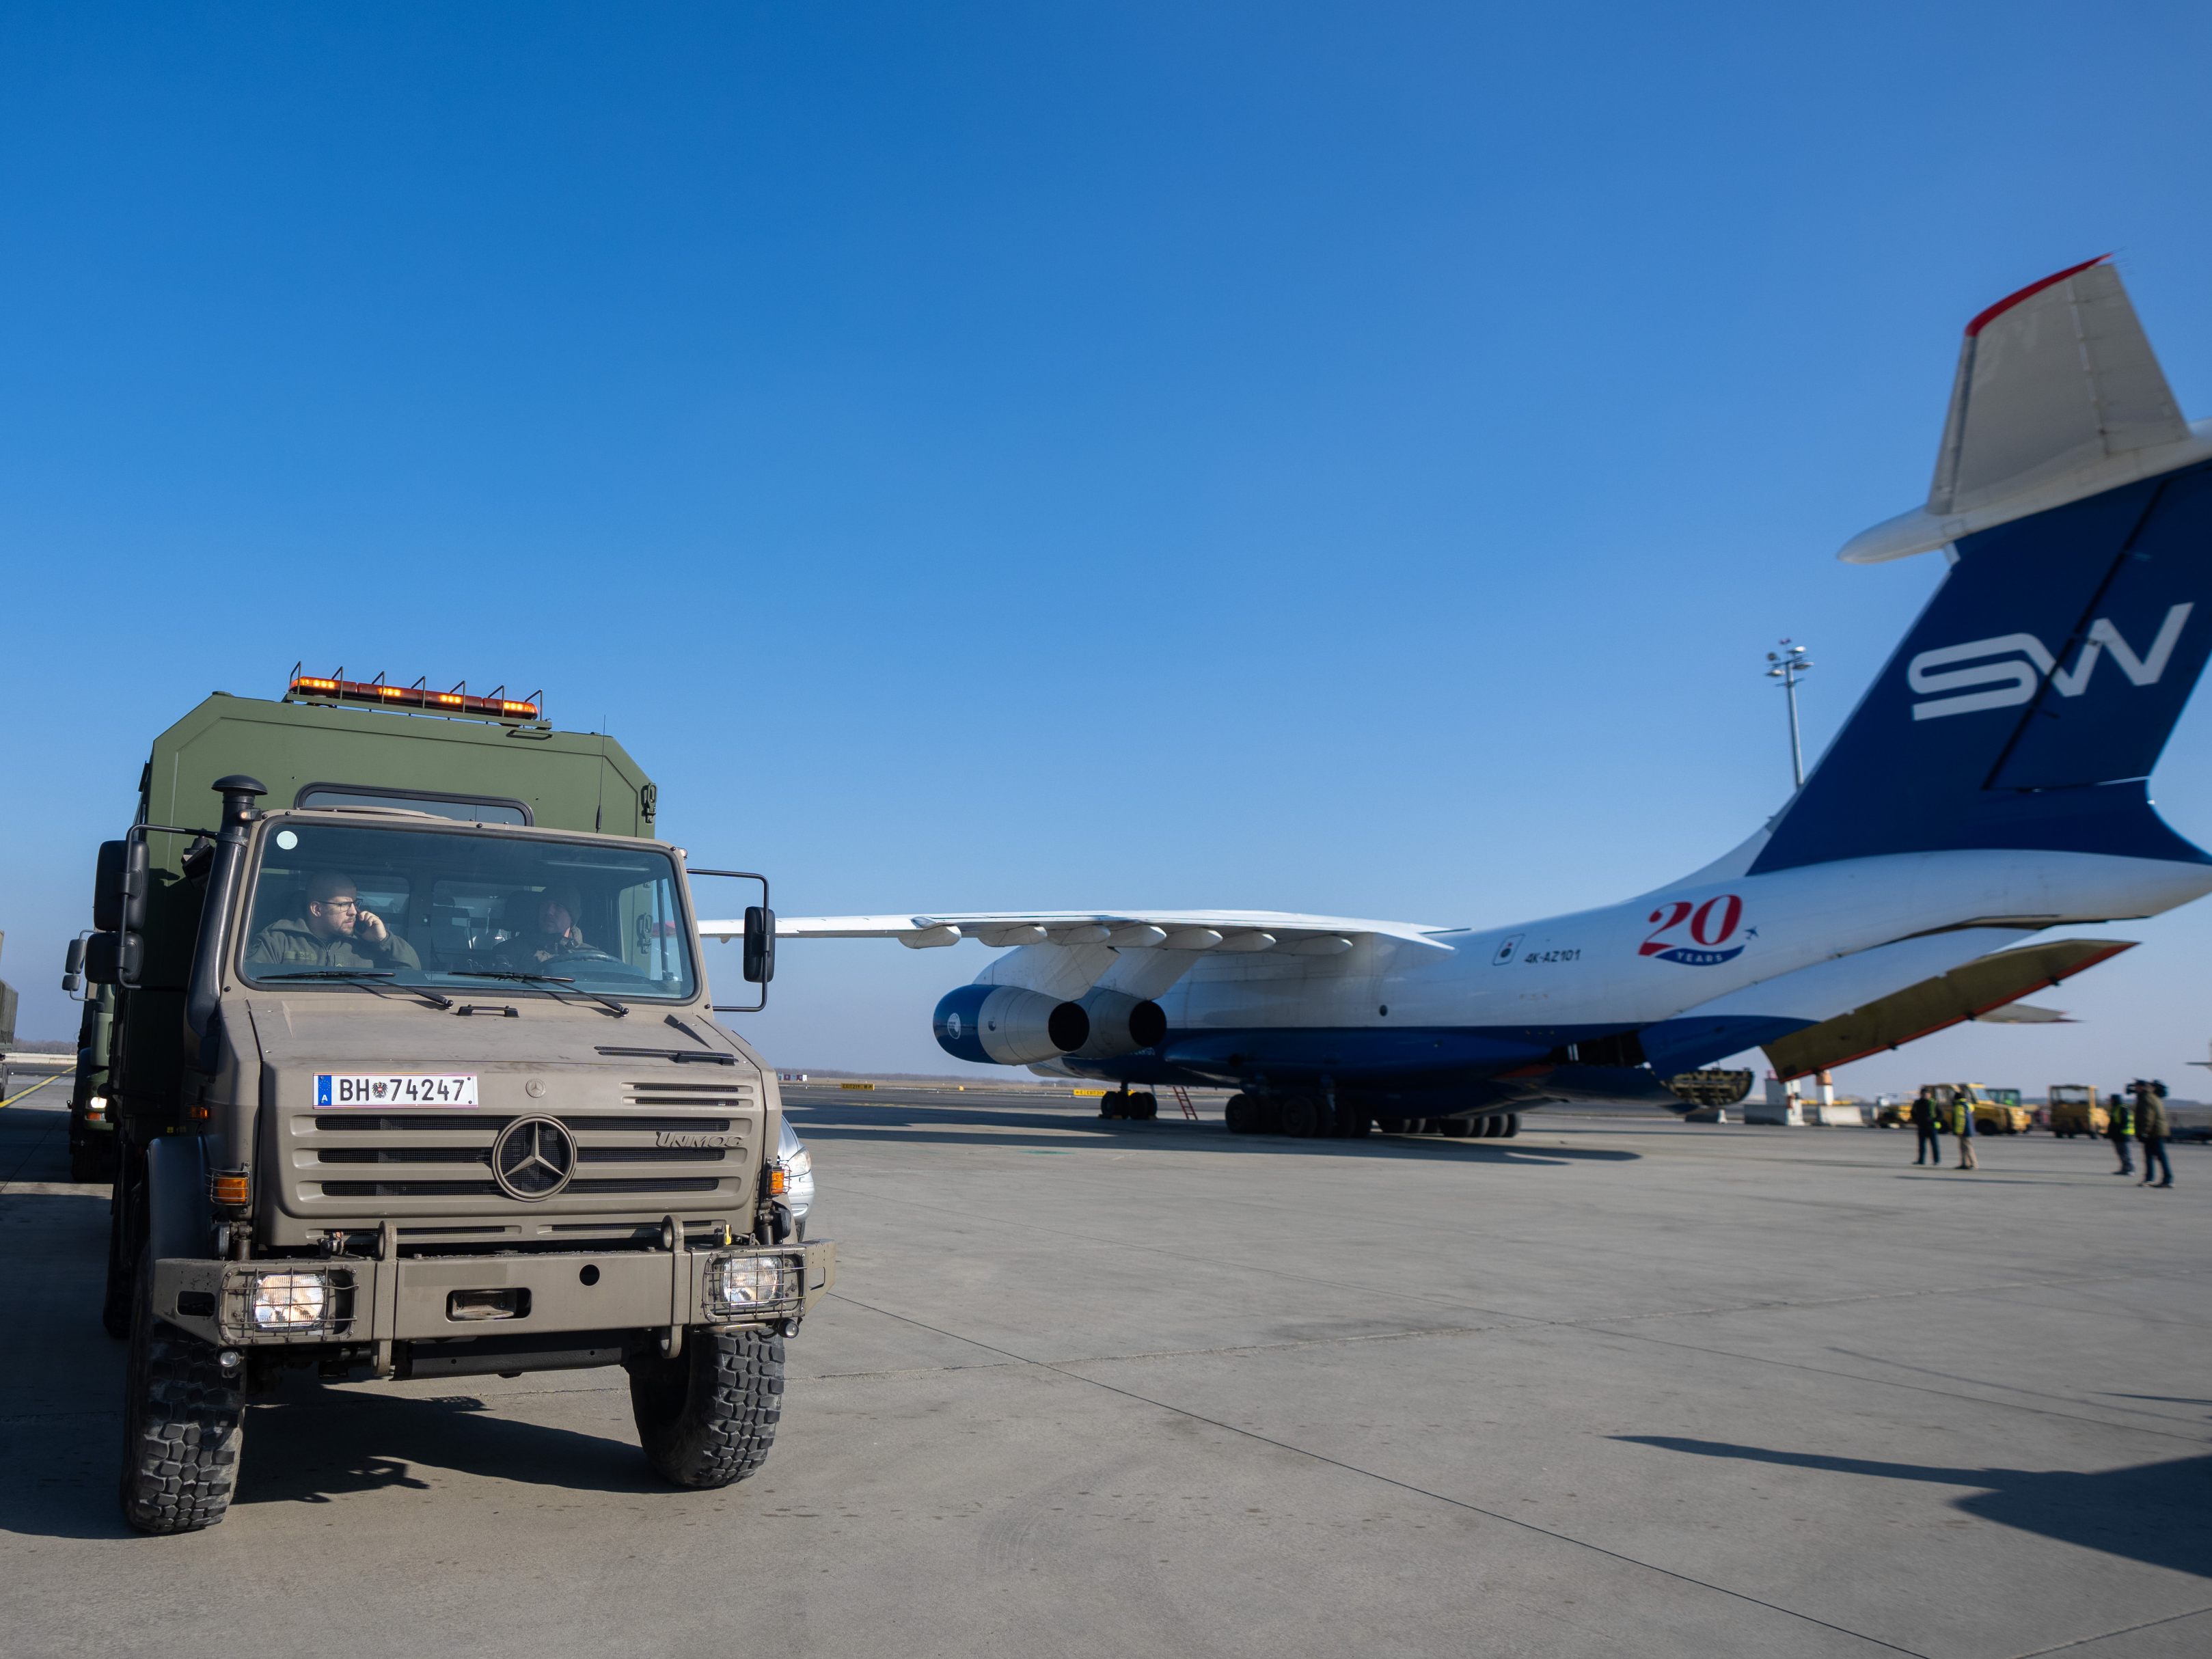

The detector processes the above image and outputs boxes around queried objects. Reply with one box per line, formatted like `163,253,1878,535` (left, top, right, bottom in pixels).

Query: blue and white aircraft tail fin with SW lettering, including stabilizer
1752,261,2212,872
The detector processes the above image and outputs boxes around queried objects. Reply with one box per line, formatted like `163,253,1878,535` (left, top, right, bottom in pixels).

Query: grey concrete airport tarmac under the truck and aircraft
0,1088,2212,1659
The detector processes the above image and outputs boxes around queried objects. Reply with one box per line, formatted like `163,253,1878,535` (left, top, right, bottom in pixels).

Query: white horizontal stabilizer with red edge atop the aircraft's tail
1840,257,2212,564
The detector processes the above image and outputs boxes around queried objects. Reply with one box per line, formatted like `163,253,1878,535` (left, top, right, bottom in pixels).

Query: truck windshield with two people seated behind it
241,821,697,1002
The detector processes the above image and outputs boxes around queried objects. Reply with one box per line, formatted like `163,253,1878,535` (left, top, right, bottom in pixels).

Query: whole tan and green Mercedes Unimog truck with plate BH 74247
80,674,834,1533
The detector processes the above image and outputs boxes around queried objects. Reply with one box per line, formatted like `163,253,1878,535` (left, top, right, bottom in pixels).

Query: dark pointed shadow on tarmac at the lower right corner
1613,1434,2212,1577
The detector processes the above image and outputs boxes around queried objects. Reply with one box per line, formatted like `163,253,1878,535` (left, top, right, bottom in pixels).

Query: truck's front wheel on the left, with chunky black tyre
120,1259,245,1533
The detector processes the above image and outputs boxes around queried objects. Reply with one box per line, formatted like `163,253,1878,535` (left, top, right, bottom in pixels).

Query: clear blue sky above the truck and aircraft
0,0,2212,1095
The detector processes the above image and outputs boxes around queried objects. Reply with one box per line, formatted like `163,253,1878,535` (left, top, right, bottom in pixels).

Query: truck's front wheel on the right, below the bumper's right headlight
628,1327,783,1491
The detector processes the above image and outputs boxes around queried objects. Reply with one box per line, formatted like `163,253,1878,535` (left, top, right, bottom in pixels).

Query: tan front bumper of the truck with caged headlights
152,1239,836,1347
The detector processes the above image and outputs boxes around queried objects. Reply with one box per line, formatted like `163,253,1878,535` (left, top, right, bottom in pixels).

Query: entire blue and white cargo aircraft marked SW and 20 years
701,259,2212,1135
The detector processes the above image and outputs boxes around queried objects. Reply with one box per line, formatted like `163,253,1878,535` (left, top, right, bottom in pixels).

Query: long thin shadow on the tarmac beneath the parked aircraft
787,1106,1643,1164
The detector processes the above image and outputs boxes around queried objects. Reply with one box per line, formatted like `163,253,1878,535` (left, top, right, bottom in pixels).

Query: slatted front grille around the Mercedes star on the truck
279,1080,761,1219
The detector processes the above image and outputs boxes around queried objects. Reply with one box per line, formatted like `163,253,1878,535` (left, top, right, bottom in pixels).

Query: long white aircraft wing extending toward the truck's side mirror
699,909,1451,956
